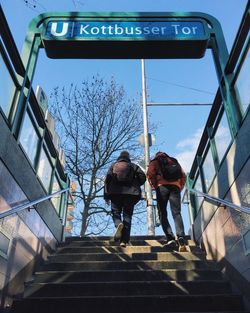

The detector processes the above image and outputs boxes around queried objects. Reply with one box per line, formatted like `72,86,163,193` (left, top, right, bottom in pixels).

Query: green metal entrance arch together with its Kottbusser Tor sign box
13,12,239,234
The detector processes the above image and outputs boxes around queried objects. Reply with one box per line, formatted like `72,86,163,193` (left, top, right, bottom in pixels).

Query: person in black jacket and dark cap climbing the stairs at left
104,151,146,247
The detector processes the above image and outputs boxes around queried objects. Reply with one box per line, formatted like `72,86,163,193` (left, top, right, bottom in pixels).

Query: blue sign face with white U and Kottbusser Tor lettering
45,20,206,40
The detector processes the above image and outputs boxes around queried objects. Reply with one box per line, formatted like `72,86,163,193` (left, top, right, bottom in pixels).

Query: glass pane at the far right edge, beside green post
234,47,250,114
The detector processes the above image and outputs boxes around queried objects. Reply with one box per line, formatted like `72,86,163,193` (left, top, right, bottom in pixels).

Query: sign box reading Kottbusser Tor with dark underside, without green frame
42,13,209,59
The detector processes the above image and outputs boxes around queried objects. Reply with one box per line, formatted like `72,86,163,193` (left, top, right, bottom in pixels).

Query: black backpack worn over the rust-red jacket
157,157,183,181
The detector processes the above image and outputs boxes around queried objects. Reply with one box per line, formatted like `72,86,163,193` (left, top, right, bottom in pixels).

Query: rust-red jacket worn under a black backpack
147,155,187,190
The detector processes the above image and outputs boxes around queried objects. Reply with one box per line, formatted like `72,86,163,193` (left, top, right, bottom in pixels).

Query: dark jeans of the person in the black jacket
111,195,138,243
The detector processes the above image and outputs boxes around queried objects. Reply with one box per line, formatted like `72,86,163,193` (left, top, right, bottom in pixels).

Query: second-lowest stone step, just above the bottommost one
24,277,231,298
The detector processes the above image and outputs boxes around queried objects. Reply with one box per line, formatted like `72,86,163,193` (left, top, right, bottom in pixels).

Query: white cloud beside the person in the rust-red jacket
176,128,203,172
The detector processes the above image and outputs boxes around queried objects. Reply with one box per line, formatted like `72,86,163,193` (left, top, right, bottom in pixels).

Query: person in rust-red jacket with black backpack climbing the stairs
147,152,186,251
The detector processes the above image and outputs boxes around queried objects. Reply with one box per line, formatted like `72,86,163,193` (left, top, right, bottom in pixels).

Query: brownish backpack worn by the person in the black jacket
112,160,135,185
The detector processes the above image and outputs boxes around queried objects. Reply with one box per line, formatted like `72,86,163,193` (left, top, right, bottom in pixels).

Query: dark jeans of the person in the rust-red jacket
156,185,185,240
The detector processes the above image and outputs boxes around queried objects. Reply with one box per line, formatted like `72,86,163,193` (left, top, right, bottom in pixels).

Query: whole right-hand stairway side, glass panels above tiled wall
189,3,250,301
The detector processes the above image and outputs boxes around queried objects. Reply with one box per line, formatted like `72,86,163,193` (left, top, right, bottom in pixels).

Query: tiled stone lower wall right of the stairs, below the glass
194,108,250,301
